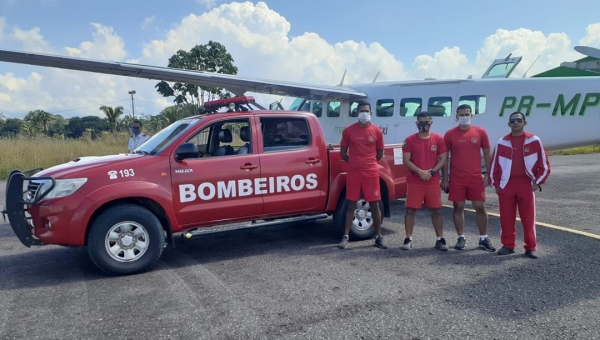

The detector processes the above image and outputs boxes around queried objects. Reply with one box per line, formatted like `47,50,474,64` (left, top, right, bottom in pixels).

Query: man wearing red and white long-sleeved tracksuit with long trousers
490,112,550,259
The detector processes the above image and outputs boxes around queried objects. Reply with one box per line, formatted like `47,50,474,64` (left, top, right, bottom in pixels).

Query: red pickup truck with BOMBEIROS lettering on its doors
3,110,408,274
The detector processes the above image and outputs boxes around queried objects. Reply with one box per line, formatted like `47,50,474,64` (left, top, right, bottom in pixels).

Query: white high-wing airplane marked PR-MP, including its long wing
0,46,600,150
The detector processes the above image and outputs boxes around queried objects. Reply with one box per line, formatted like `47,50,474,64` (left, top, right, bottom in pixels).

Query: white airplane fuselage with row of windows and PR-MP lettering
294,77,600,150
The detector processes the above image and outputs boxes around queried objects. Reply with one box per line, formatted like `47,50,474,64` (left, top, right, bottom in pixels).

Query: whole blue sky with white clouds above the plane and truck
0,0,600,118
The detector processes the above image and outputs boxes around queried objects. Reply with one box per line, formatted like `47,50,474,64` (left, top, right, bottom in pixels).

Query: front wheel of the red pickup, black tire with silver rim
88,204,165,275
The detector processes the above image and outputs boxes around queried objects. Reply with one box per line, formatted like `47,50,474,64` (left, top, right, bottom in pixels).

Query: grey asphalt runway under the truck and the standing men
0,154,600,339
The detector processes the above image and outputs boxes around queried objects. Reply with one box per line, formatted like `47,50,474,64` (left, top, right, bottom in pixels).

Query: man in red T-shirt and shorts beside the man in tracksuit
441,104,496,252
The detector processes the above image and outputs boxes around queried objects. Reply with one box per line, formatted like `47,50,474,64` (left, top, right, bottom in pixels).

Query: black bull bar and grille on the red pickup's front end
2,168,56,248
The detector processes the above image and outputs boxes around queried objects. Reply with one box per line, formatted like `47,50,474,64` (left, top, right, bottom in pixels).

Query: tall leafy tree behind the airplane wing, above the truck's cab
155,40,238,107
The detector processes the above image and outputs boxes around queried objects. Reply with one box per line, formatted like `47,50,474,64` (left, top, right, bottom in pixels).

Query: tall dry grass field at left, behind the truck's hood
0,133,129,180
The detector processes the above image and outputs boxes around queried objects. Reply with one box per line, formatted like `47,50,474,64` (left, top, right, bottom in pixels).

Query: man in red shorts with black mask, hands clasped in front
400,112,448,251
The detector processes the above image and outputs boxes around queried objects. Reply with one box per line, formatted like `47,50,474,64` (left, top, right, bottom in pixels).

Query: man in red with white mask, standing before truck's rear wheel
338,102,387,249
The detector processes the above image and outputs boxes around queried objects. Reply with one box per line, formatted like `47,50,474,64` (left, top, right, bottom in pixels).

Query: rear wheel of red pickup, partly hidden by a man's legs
333,197,383,240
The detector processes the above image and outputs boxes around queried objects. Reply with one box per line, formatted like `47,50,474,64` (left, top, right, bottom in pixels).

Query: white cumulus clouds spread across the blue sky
0,2,600,116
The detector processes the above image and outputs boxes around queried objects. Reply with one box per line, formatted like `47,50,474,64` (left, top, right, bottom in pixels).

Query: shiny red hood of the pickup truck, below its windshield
35,153,144,178
